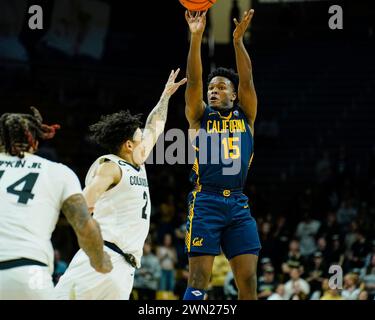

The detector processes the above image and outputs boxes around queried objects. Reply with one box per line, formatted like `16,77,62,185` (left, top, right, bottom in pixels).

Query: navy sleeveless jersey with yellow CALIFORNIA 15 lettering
190,106,254,189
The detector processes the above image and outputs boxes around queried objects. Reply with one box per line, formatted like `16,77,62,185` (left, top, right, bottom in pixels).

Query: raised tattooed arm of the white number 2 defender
133,69,187,165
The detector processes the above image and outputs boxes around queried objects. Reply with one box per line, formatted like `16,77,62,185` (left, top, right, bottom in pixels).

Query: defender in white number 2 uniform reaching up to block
56,69,186,300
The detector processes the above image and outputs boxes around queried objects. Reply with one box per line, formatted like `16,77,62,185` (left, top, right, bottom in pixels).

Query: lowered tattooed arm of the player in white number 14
61,194,112,273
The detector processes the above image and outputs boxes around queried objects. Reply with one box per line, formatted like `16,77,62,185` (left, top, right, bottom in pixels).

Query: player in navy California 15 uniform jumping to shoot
184,10,261,300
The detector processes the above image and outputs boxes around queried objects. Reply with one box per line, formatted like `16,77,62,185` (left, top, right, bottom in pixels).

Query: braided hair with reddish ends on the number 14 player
0,107,60,158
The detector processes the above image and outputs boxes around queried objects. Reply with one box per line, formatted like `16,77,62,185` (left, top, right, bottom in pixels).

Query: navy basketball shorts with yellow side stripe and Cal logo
185,190,261,260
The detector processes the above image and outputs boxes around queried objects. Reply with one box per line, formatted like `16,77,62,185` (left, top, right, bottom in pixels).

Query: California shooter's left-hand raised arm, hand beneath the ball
185,11,207,129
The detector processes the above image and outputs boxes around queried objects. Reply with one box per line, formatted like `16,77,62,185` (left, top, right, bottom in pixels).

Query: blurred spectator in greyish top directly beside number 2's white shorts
134,242,161,300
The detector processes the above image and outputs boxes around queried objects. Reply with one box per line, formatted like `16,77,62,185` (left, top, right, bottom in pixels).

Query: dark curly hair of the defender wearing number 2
89,110,142,154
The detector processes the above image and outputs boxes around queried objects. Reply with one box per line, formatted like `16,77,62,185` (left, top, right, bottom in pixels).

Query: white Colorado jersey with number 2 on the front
86,154,151,268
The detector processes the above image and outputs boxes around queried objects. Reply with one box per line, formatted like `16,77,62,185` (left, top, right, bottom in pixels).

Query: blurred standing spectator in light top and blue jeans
157,233,177,291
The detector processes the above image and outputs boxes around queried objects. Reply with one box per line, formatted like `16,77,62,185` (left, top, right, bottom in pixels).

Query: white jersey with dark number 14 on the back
0,153,82,272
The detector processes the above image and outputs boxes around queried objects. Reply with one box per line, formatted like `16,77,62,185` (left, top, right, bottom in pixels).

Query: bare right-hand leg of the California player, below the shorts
229,254,258,300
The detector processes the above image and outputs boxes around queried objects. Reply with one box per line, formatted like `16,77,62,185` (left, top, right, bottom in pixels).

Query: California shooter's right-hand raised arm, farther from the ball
233,9,258,128
